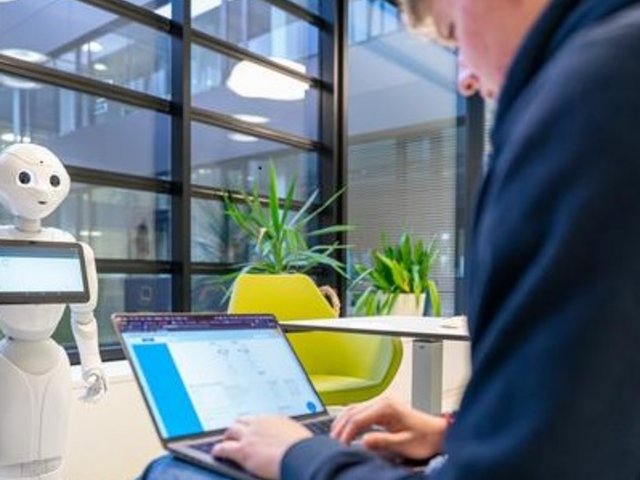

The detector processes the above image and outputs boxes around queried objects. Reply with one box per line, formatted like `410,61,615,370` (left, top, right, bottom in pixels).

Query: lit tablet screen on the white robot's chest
0,244,85,295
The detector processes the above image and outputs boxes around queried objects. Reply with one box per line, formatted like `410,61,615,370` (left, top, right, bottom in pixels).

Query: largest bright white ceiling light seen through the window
227,58,309,101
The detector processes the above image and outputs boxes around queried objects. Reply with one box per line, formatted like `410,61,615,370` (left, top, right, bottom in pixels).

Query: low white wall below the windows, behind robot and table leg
65,339,469,480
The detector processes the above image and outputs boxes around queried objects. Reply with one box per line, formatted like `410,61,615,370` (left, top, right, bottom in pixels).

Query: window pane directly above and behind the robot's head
0,74,171,178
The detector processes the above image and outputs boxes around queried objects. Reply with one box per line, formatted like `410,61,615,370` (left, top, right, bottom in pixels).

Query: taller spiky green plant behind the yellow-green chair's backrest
224,164,352,308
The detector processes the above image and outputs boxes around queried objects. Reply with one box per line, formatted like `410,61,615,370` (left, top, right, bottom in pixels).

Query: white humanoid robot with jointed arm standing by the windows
0,144,107,480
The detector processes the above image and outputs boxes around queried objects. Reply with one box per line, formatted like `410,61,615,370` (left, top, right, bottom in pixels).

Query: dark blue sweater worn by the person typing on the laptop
282,0,640,480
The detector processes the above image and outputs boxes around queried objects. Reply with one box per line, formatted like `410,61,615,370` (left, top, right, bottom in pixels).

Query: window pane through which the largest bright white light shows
191,45,318,139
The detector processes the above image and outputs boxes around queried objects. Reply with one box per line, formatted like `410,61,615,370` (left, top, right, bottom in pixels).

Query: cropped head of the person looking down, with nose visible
401,0,551,98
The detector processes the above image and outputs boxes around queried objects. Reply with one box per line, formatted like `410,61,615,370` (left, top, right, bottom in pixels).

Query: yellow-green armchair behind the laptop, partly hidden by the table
229,274,402,405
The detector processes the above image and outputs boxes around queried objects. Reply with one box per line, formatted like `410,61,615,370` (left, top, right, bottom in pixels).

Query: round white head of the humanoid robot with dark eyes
0,143,71,220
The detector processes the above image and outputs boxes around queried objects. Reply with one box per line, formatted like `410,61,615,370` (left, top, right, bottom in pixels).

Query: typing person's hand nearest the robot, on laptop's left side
212,416,312,480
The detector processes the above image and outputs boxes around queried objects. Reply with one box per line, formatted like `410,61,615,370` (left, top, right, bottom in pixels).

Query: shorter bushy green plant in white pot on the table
353,233,441,316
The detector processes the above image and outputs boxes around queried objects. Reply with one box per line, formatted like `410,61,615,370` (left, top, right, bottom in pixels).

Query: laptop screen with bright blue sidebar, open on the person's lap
119,315,324,440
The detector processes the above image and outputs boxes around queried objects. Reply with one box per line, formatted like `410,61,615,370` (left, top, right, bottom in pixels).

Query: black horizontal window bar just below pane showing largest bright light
191,107,320,151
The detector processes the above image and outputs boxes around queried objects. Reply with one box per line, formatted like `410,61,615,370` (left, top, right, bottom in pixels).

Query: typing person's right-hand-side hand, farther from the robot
331,398,447,460
